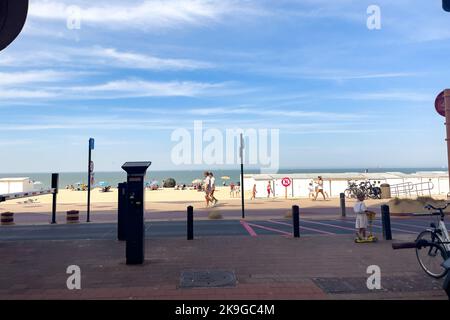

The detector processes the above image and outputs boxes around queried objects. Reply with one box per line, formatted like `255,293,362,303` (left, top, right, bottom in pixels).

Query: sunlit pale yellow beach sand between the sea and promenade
0,187,385,213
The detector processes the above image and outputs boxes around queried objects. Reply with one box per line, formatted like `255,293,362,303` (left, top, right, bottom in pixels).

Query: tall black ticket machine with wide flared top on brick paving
122,162,152,264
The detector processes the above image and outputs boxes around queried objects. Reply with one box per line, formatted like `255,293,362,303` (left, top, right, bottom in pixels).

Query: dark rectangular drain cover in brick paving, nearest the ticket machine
180,270,236,288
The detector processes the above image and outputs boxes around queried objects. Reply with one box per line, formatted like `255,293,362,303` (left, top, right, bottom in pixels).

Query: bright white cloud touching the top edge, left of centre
29,0,255,30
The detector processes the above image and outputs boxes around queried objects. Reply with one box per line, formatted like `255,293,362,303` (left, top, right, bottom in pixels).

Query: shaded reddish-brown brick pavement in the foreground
0,235,446,300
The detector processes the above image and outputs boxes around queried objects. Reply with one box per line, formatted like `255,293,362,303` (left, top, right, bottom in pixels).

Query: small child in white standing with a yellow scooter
353,193,378,243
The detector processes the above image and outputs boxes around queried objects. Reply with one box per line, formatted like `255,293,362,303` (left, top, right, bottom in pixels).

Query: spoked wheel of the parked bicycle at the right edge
416,230,448,279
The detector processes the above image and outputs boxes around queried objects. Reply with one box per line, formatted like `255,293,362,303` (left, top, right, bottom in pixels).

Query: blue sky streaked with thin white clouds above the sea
0,0,450,172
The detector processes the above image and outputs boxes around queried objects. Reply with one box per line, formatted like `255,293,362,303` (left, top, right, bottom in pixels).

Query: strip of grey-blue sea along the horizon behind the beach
0,168,446,188
